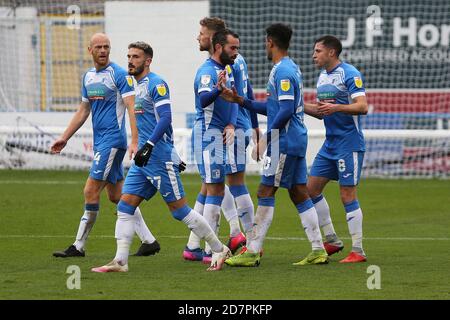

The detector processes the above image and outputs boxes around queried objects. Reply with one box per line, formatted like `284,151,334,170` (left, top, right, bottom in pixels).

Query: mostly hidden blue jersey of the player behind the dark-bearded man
232,54,252,131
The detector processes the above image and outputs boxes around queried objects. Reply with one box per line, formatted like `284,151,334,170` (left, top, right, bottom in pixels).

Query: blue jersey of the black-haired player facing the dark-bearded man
267,57,308,157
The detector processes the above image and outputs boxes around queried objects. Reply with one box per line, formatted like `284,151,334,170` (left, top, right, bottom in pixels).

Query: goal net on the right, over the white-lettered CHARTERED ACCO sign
210,0,450,178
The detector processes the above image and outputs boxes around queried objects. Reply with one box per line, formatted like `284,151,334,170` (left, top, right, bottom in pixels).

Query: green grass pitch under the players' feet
0,170,450,300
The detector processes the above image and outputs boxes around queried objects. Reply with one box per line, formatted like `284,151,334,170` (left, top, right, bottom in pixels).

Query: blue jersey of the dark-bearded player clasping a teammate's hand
194,58,233,131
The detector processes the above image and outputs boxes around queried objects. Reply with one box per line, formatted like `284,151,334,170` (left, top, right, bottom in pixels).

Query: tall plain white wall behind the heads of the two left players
105,1,209,127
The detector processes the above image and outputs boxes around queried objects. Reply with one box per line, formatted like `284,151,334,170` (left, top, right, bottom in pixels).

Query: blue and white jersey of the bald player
81,62,135,149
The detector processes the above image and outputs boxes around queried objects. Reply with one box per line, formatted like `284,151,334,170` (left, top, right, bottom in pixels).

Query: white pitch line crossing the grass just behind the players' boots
0,234,450,241
